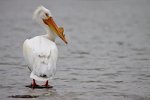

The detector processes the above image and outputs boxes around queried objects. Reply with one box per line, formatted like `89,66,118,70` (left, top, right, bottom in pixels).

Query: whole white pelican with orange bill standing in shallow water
23,6,67,88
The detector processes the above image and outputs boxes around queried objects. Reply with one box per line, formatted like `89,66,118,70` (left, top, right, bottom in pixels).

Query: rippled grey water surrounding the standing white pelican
0,0,150,100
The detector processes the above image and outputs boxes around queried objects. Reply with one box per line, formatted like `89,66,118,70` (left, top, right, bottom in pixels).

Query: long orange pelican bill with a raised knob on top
43,17,68,44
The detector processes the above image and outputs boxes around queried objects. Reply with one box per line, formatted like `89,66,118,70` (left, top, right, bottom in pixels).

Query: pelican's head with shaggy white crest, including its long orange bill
33,6,67,44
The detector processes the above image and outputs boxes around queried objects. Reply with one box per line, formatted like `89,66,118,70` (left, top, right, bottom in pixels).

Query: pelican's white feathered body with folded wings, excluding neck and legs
23,36,58,81
